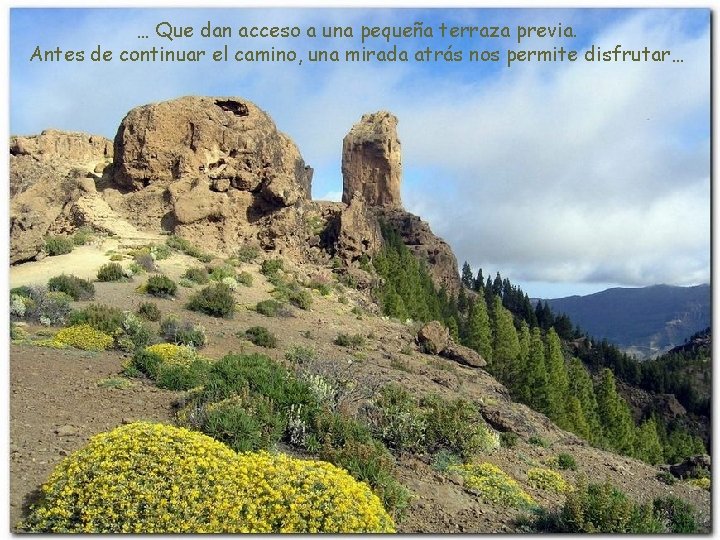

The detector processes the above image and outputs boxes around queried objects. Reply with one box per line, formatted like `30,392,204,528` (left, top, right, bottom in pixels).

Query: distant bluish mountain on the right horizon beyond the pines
547,284,711,358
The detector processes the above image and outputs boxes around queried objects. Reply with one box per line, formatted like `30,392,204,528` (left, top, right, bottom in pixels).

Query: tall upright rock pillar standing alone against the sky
342,111,402,208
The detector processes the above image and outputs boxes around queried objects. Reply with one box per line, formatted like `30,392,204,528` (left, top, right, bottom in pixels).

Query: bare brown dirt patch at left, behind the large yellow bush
10,345,177,530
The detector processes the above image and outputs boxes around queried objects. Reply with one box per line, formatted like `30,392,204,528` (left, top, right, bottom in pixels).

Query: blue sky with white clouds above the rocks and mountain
9,8,711,298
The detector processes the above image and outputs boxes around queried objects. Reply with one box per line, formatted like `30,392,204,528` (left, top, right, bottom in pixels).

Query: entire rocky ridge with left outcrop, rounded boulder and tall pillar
10,96,459,298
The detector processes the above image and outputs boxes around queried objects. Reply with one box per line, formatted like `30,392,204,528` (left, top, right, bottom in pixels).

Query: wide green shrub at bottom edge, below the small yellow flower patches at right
535,480,664,534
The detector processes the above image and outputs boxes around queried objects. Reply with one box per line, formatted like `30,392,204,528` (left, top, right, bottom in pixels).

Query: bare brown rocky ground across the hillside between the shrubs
10,239,710,533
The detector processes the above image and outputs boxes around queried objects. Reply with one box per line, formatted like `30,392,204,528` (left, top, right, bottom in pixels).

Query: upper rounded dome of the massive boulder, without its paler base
113,96,312,208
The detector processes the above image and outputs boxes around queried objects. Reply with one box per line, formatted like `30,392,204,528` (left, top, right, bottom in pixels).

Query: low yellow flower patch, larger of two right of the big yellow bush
448,463,536,507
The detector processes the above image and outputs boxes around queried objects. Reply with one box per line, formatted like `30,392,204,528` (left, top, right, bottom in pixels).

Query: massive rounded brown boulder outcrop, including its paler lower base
105,96,312,252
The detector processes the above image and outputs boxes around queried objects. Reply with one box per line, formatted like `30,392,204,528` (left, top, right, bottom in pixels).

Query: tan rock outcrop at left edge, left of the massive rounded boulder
10,130,112,264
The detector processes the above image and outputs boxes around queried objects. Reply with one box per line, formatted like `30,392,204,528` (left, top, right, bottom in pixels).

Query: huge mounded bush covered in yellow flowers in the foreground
21,422,394,533
